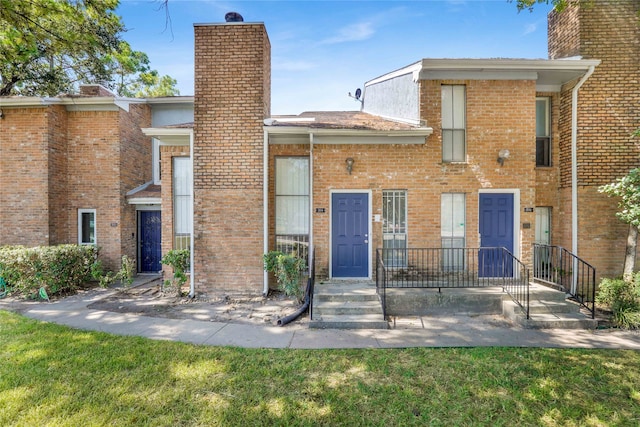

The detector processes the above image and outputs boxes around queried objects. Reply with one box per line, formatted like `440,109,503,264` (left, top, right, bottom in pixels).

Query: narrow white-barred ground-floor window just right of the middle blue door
382,190,407,267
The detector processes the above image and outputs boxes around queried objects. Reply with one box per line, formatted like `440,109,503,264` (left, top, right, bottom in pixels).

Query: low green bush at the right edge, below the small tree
596,272,640,329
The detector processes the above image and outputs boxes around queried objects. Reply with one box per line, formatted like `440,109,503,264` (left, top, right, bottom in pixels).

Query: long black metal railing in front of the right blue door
376,248,529,318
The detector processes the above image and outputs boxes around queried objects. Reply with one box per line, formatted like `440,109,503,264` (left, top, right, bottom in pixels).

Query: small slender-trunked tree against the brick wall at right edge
598,169,640,282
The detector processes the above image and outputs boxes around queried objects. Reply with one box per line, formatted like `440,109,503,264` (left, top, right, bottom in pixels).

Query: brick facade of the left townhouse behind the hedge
0,86,151,269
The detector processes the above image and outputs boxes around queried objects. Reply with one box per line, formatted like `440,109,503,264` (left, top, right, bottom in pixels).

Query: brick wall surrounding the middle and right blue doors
269,81,536,277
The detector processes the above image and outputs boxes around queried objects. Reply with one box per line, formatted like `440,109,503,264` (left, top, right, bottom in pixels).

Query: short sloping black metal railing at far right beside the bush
533,243,596,319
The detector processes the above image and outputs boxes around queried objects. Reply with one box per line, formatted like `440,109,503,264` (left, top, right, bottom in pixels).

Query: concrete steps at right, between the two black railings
503,301,598,329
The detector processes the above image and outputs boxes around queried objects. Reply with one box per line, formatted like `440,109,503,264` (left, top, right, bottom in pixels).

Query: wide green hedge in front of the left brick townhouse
0,245,98,296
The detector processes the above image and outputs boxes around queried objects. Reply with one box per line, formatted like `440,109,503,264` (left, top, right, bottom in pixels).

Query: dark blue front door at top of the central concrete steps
331,193,369,277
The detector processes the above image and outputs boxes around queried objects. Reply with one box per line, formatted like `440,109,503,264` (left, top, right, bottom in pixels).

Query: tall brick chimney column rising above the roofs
193,22,271,294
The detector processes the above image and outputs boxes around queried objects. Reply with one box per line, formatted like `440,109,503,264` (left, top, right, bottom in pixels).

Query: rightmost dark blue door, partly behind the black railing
478,193,513,277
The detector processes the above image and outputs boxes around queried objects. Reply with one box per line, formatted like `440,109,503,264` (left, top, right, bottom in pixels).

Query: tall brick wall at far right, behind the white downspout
549,0,640,276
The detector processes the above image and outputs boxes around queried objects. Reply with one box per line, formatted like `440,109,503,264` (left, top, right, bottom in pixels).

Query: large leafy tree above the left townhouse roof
0,0,177,96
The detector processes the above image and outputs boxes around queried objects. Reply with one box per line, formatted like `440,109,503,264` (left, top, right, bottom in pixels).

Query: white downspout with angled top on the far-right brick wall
571,65,595,295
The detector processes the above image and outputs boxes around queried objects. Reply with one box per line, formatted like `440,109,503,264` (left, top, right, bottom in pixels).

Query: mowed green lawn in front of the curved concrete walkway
0,311,640,426
